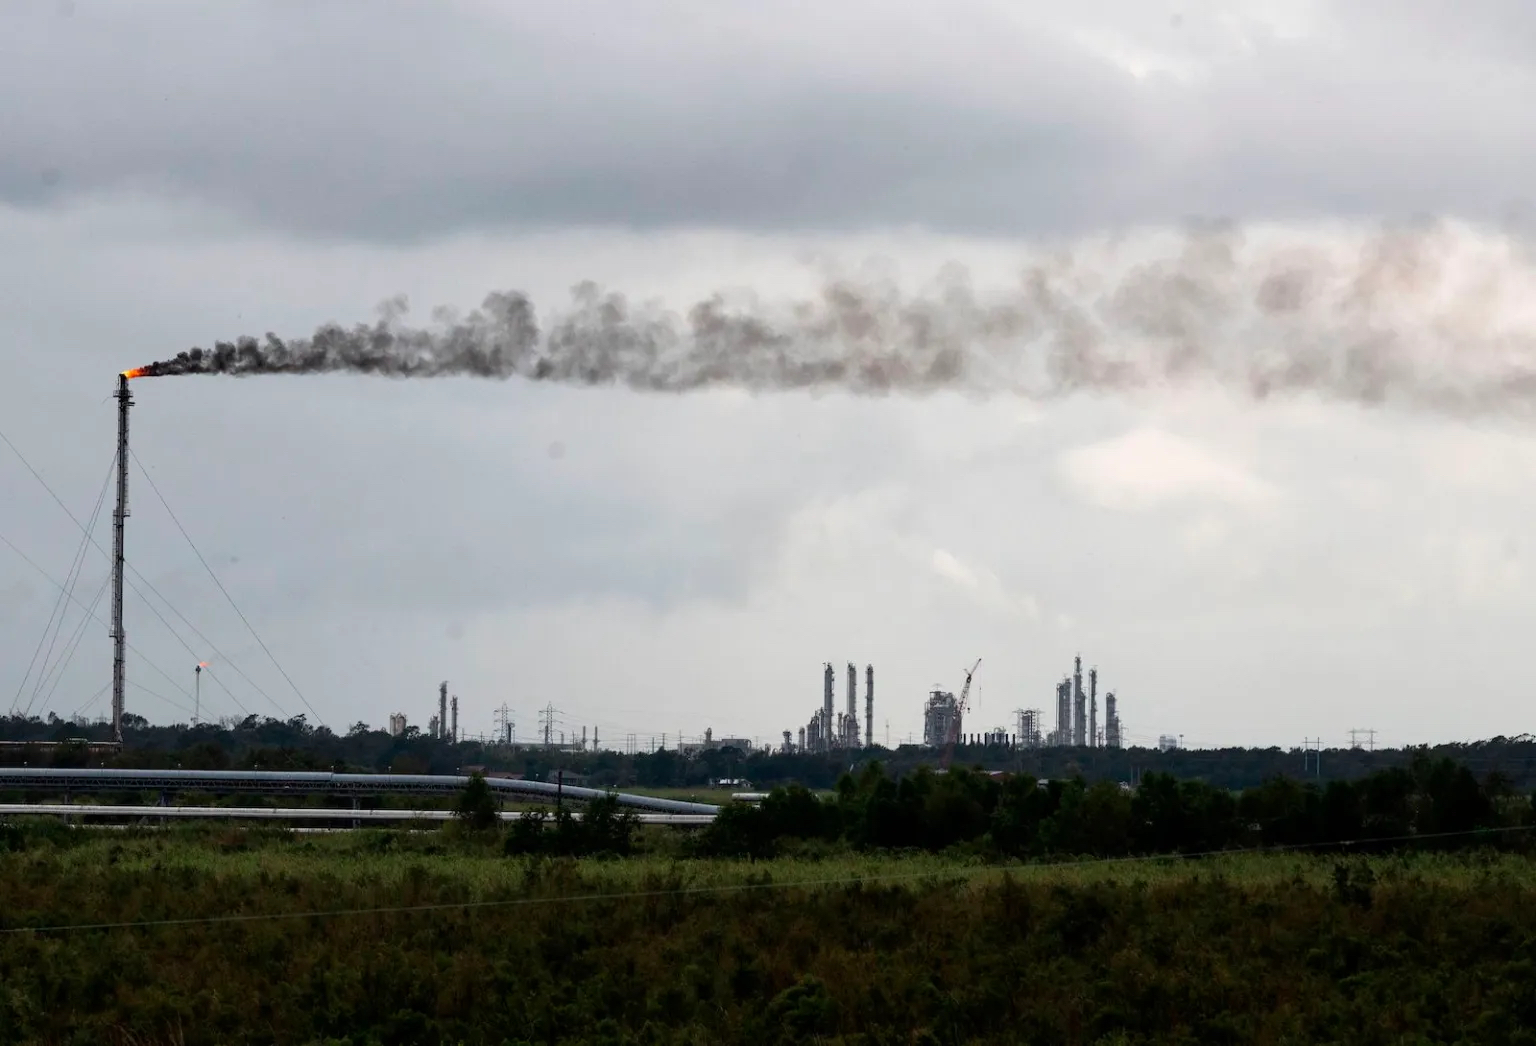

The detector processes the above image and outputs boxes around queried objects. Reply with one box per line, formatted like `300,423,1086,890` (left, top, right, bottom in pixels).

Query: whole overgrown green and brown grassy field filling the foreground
0,823,1536,1046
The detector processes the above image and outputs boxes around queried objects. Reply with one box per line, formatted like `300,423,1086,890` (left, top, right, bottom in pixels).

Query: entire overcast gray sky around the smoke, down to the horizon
0,0,1536,746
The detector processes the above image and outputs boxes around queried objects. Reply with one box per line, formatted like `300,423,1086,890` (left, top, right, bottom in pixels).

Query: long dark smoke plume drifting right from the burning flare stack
129,223,1536,415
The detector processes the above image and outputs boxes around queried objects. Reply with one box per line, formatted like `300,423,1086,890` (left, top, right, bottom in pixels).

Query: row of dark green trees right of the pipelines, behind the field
696,753,1536,859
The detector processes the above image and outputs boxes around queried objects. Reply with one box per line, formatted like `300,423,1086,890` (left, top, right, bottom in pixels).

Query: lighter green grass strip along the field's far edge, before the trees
12,825,1536,897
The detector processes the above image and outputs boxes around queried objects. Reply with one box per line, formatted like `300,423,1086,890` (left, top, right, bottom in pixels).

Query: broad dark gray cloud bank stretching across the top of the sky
0,0,1536,241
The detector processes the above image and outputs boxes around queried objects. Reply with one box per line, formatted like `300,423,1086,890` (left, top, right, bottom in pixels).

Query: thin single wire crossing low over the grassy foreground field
0,811,1536,934
